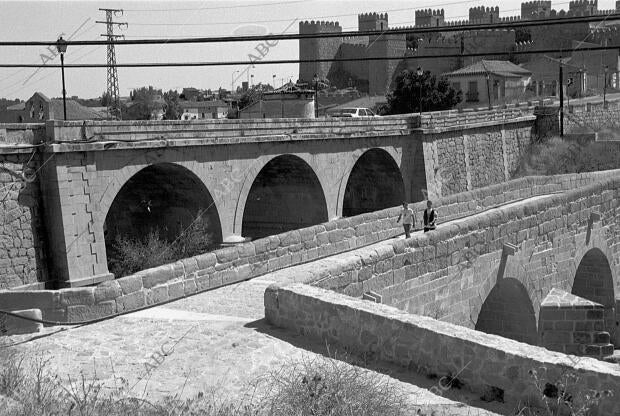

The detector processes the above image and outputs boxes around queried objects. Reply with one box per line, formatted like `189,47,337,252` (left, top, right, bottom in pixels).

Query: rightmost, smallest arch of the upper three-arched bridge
337,148,407,217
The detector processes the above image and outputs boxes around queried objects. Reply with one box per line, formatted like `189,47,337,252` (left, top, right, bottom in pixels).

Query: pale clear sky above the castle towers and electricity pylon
0,0,615,99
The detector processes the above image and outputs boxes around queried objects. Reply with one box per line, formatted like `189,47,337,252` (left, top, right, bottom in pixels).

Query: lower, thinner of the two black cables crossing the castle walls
0,45,620,68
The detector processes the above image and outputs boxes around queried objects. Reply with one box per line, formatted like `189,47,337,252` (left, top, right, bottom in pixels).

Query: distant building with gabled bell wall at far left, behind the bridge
0,92,107,123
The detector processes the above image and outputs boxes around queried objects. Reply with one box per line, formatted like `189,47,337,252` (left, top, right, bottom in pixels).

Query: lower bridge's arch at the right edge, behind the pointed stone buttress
571,248,617,334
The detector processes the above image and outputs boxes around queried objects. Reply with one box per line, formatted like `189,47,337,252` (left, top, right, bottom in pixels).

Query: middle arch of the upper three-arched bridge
234,154,328,239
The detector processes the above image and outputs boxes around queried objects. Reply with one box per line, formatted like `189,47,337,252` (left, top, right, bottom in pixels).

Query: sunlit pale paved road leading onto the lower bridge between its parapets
0,196,560,416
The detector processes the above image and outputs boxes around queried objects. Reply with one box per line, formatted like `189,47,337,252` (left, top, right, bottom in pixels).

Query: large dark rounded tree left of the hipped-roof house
382,70,463,114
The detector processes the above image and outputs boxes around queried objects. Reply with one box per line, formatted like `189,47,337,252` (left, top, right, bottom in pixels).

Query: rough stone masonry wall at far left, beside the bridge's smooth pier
0,124,48,289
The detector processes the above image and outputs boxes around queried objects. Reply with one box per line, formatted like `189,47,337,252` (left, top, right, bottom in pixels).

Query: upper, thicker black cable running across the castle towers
0,13,620,46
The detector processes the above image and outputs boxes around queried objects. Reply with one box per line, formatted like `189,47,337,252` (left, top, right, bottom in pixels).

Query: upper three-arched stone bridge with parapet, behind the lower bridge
0,107,535,288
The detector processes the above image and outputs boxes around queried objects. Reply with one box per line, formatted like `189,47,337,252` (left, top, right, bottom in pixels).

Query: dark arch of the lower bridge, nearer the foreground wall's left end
475,277,538,345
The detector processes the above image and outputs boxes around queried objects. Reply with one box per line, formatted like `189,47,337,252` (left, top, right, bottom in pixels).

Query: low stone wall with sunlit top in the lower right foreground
265,284,620,415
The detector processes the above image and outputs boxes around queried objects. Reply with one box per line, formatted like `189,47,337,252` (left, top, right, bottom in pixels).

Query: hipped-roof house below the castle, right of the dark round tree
444,60,532,104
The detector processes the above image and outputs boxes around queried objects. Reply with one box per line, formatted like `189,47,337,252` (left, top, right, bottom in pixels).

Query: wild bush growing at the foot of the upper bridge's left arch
110,211,214,277
